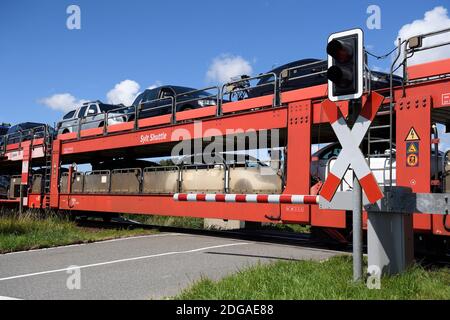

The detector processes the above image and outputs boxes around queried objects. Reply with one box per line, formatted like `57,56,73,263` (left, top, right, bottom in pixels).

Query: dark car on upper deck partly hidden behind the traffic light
248,59,402,98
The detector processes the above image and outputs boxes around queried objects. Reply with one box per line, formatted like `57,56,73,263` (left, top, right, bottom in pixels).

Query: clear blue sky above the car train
0,0,450,123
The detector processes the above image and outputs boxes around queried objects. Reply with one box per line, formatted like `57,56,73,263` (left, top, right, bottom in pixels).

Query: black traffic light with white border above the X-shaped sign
327,29,364,101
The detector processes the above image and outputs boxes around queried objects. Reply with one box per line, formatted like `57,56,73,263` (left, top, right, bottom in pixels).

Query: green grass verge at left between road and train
0,213,156,254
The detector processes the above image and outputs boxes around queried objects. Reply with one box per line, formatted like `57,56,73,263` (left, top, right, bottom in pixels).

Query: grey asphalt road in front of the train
0,233,336,300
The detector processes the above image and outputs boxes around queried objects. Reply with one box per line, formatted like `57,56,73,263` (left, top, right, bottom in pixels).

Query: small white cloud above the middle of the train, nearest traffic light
206,54,253,83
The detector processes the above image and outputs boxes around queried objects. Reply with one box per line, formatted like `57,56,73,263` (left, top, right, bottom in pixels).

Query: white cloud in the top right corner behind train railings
395,6,450,65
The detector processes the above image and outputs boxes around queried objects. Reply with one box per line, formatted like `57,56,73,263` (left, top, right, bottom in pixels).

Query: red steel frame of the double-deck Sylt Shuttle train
0,59,450,236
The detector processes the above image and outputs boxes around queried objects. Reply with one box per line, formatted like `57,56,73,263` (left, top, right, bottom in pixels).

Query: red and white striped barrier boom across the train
173,193,320,205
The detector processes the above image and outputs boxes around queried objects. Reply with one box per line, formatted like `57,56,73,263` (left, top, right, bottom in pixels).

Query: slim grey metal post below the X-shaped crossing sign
353,175,363,281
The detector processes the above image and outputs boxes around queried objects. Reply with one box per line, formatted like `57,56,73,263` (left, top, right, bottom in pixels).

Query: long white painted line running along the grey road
0,242,250,281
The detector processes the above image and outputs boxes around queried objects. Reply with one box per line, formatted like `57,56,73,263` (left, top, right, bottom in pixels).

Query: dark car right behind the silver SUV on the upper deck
133,85,217,119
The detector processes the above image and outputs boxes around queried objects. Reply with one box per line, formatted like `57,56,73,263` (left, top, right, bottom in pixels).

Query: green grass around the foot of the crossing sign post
175,256,450,300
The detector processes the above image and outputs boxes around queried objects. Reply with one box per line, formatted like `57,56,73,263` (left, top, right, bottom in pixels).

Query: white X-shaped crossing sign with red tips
320,93,384,203
